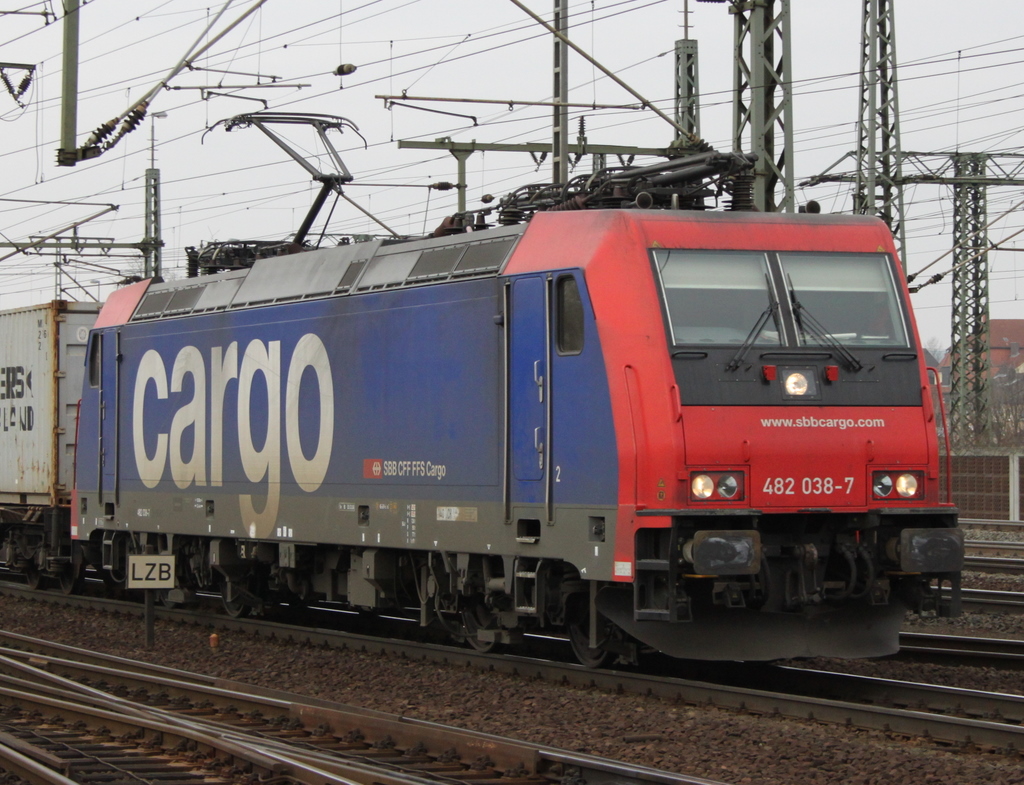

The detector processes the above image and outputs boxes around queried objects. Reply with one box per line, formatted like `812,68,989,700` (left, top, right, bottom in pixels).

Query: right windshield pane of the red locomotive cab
779,254,909,347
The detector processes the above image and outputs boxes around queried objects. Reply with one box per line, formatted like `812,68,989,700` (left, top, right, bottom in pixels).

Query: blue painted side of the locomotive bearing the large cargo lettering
77,276,615,541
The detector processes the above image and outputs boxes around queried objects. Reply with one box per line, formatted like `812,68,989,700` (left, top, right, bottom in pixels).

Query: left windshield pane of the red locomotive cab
653,249,779,345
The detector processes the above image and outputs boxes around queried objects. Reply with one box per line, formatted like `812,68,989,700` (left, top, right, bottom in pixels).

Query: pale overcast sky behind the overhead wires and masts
0,0,1024,347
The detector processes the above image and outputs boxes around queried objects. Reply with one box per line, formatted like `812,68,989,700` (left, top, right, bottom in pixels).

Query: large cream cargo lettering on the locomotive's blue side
132,333,335,537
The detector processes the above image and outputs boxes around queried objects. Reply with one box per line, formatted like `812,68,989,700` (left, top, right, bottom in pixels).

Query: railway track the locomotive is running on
0,588,1024,749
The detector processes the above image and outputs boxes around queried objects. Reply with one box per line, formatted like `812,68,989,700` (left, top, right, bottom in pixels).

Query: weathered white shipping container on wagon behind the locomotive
0,300,99,507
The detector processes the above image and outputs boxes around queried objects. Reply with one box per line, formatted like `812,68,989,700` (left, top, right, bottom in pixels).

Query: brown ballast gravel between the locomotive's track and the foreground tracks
0,597,1024,785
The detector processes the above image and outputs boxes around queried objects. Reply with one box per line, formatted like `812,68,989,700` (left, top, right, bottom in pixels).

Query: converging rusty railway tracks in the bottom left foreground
0,634,715,785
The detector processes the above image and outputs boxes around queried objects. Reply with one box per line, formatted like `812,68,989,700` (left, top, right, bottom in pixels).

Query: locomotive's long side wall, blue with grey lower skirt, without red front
74,225,618,637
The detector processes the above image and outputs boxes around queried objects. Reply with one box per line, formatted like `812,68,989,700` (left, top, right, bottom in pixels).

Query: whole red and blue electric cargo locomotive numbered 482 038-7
6,154,964,666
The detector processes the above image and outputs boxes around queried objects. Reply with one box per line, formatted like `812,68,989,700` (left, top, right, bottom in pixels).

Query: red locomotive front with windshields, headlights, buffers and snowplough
507,211,963,659
